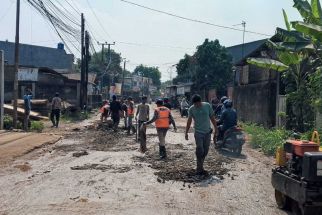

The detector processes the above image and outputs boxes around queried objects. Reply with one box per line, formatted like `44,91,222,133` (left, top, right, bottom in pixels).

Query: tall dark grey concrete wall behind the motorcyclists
233,82,276,127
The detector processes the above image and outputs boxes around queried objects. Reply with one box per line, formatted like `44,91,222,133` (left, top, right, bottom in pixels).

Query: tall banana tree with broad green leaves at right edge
248,0,322,130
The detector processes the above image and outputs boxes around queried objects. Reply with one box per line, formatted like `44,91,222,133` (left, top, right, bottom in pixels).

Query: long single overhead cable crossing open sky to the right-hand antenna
118,0,272,37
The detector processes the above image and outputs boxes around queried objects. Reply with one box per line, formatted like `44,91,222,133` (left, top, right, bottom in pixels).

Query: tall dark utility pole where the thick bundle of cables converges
79,13,85,110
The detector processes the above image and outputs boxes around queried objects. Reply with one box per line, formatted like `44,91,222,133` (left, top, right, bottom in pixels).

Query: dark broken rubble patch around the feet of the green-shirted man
133,150,231,183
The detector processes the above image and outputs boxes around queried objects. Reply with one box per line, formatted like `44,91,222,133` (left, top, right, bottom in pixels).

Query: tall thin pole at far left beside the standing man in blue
12,0,20,128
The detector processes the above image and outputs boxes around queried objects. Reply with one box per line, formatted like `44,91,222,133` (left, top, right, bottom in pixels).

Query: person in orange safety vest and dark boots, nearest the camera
144,99,177,159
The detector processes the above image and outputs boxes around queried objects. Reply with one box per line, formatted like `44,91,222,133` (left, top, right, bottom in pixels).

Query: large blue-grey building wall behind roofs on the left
0,41,74,73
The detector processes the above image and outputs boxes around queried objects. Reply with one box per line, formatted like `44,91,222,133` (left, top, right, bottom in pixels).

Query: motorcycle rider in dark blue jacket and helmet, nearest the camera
217,99,237,140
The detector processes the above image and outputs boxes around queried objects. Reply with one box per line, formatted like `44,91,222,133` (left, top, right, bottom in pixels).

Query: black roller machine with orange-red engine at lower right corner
272,132,322,215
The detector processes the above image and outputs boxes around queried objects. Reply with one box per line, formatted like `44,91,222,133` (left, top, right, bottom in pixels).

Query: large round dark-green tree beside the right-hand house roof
174,39,232,91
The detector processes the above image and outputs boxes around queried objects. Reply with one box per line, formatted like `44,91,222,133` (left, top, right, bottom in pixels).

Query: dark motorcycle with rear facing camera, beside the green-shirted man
215,126,245,156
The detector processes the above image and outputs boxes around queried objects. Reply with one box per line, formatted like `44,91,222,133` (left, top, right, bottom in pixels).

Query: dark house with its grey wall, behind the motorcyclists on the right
228,36,286,127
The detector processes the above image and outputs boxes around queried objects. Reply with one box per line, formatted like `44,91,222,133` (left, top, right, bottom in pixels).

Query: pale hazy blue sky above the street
0,0,299,81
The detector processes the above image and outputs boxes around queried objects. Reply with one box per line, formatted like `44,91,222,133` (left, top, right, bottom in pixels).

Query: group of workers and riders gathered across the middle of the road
100,94,237,175
